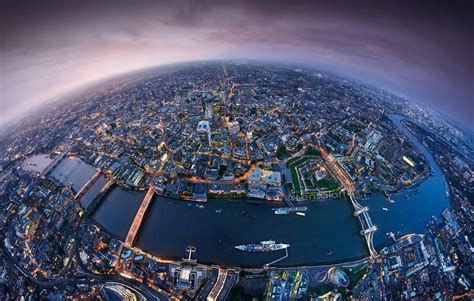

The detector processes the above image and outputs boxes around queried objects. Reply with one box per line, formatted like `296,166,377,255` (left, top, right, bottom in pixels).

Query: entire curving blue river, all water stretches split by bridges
27,115,449,267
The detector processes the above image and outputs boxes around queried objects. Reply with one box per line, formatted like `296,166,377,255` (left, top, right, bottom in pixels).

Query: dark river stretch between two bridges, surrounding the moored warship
137,197,367,267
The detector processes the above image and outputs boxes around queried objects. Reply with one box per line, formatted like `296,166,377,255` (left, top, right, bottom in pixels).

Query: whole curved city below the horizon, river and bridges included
0,60,474,300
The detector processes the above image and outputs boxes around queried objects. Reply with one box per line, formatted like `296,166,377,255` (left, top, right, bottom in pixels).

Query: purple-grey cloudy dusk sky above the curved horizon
0,0,474,130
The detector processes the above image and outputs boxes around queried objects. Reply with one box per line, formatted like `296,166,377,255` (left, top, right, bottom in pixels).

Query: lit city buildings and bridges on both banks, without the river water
0,61,474,300
